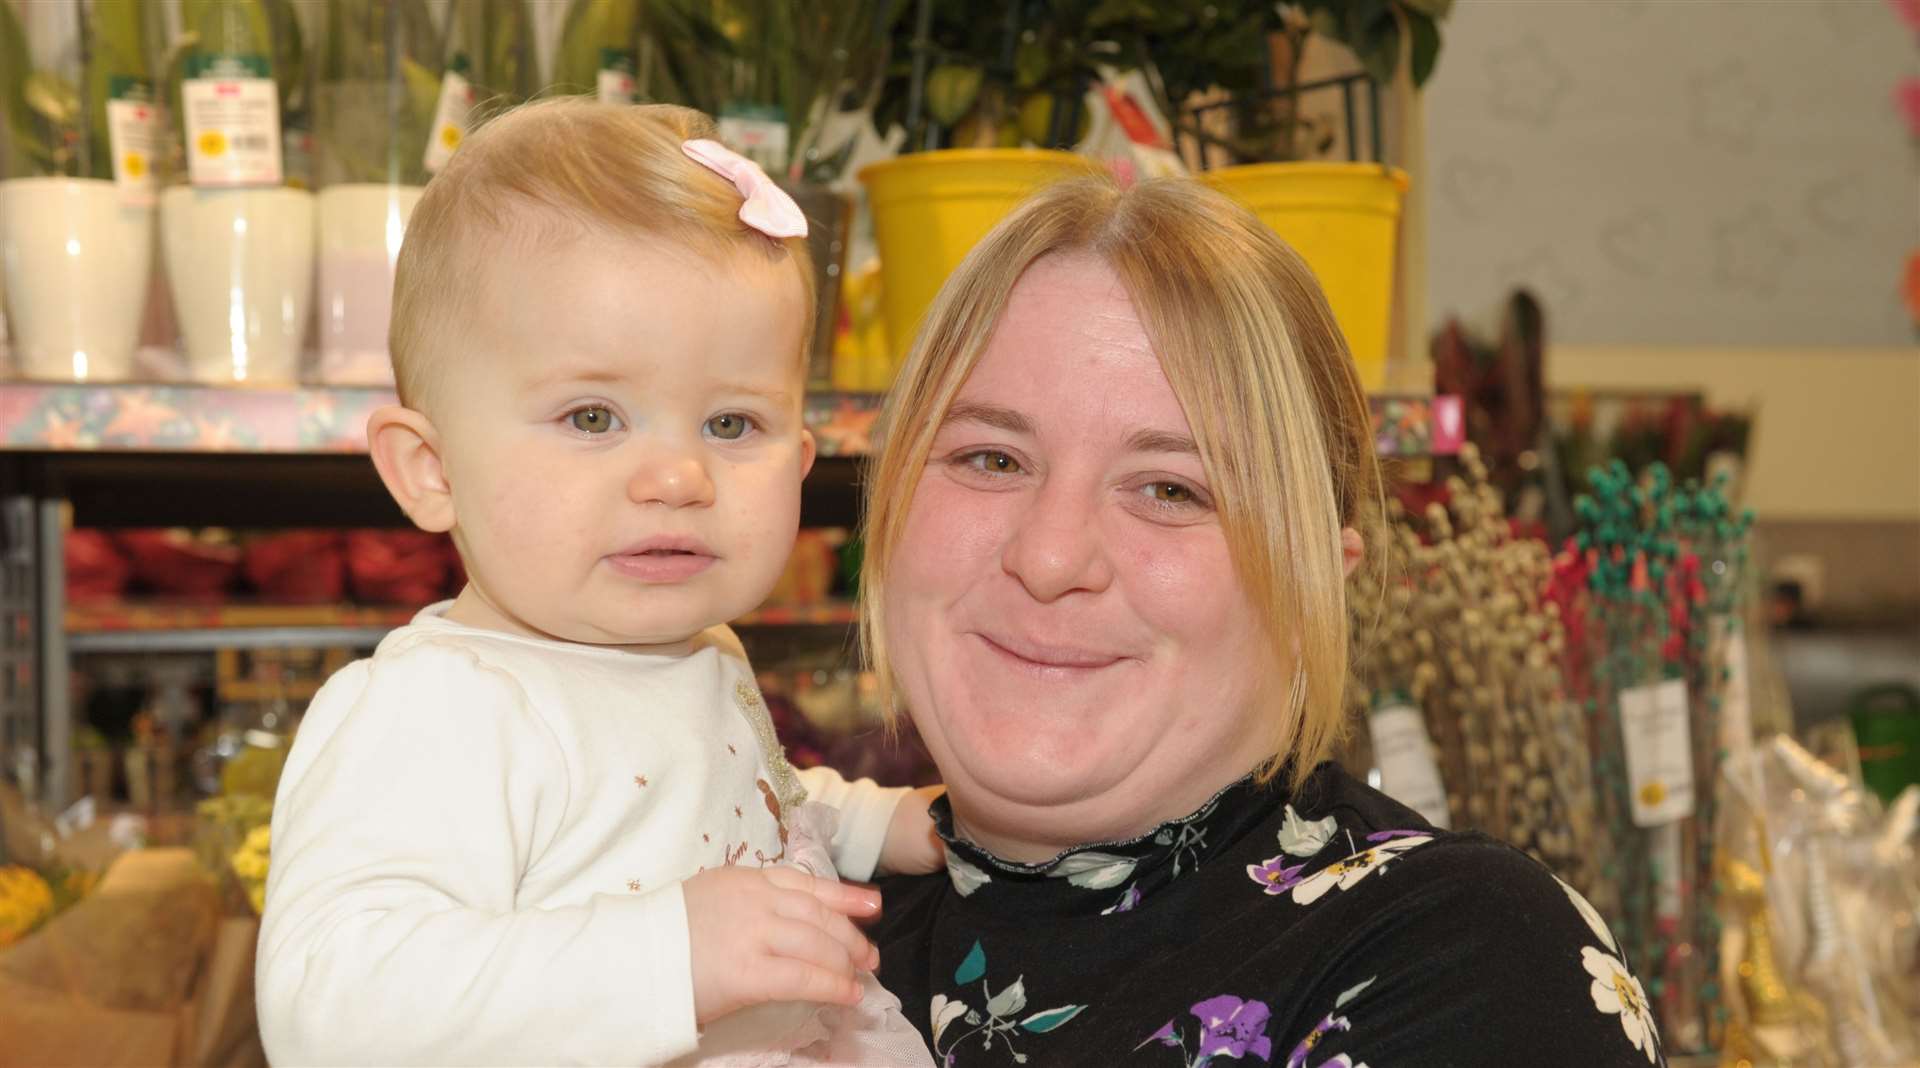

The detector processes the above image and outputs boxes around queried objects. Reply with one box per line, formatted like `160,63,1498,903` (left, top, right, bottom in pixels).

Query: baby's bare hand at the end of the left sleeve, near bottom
682,868,879,1028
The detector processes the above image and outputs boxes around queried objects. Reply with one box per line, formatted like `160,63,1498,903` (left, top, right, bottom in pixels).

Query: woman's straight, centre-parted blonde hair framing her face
860,177,1380,780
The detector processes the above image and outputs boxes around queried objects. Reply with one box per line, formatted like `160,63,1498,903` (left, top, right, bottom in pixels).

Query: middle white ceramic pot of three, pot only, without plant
159,186,313,386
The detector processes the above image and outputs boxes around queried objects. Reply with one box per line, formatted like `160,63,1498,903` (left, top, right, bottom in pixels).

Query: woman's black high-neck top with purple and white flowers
874,763,1665,1068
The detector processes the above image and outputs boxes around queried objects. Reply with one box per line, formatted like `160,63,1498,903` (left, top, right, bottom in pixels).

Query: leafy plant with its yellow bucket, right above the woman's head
1104,0,1452,390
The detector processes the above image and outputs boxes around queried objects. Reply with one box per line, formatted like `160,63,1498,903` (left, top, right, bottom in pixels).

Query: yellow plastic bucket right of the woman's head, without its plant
1200,163,1407,392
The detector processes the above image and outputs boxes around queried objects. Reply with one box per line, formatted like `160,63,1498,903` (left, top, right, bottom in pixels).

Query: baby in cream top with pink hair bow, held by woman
257,100,941,1064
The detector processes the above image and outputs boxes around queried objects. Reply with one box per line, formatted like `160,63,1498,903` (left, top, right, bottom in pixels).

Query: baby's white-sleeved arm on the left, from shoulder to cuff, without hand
257,645,697,1064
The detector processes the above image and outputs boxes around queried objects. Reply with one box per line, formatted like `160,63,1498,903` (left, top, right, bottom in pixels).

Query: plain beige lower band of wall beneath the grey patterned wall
1548,346,1920,521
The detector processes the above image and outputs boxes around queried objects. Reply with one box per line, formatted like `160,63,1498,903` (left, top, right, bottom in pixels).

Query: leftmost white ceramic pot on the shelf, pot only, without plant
0,179,154,382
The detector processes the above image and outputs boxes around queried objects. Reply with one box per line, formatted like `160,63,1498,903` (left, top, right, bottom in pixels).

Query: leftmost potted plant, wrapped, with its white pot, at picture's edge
0,0,157,380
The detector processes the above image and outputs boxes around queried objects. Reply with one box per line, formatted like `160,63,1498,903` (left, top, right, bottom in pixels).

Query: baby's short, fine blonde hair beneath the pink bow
388,96,814,409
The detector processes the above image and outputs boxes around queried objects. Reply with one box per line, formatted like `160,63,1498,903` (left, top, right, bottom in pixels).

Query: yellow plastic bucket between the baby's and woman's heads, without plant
860,148,1096,365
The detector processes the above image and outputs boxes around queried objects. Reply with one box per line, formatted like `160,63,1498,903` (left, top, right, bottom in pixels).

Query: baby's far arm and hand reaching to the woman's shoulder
799,765,945,880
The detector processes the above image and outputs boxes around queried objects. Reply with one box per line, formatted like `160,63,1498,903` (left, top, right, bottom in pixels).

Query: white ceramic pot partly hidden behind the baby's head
319,182,420,386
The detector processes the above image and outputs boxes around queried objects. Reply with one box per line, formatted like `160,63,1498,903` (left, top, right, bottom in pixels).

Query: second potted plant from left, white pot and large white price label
159,0,313,386
